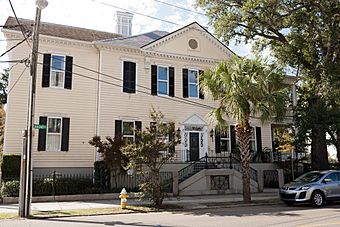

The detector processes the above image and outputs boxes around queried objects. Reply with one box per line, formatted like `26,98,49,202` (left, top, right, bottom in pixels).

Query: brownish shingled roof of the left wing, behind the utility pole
4,17,121,42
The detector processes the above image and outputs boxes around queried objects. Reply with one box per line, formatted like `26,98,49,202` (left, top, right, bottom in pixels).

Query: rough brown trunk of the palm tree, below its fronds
236,120,252,202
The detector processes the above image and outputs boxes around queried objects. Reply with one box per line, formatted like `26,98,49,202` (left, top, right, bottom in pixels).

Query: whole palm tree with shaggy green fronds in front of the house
200,57,289,201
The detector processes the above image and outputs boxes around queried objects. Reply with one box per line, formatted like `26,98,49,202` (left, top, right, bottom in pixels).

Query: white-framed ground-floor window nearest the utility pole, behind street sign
46,117,62,151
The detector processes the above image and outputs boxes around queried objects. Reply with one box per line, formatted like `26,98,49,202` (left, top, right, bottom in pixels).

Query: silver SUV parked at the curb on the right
280,170,340,207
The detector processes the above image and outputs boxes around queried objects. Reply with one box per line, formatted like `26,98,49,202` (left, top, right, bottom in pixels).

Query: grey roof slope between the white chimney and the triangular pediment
97,31,169,48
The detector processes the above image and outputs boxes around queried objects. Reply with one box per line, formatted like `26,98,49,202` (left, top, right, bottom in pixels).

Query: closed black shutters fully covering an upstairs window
123,61,136,93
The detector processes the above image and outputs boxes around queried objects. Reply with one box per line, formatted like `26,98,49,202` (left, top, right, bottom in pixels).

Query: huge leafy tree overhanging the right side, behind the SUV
197,0,340,169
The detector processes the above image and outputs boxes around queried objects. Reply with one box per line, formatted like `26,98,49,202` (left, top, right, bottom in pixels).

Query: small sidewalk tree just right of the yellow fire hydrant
122,108,180,207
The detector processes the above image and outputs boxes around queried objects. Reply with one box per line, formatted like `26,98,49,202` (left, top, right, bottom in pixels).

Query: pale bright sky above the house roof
0,0,250,71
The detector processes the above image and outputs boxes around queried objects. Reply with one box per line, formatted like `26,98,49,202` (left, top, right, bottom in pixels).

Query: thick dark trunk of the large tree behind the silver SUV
311,125,329,170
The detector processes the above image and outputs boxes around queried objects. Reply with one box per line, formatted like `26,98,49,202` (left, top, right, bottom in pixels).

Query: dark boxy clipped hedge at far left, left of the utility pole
1,155,21,181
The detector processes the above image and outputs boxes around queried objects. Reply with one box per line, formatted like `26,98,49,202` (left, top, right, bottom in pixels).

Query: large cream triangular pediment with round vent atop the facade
142,22,233,60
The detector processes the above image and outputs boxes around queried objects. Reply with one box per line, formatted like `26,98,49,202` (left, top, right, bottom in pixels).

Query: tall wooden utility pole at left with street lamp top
19,0,48,217
